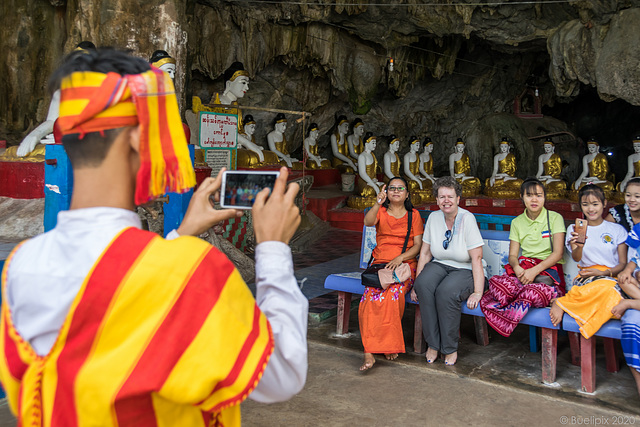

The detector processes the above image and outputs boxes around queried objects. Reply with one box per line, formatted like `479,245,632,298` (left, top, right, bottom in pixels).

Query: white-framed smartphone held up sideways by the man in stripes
220,171,280,209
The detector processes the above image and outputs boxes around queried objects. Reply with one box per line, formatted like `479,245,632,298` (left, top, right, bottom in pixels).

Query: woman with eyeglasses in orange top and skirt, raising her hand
358,177,422,371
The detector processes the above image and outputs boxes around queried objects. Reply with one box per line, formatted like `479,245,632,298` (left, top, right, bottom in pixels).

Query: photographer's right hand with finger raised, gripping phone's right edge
252,167,300,244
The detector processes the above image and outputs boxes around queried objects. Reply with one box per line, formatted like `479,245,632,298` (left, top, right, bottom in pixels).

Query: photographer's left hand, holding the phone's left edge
176,168,242,236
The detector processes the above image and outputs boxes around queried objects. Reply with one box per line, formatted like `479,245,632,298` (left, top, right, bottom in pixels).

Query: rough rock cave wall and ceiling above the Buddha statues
0,0,640,179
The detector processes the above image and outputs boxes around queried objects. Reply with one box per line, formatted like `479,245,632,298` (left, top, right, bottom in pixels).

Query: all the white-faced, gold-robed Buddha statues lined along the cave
2,46,640,209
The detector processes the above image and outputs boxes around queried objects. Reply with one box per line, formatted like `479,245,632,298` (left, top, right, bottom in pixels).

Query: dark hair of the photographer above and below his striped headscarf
49,48,151,168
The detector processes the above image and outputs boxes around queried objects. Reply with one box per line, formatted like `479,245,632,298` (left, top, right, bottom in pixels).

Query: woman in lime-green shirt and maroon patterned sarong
480,178,566,337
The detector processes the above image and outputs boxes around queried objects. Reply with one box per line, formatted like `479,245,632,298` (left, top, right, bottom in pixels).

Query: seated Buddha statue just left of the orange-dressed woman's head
347,132,383,209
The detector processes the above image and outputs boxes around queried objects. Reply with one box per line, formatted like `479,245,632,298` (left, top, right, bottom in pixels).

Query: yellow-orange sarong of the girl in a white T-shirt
556,265,622,339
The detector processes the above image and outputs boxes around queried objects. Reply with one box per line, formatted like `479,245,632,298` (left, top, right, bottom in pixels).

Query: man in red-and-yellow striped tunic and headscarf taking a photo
0,50,308,426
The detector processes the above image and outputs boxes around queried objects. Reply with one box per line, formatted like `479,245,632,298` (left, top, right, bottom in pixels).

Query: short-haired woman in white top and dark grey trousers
411,176,484,366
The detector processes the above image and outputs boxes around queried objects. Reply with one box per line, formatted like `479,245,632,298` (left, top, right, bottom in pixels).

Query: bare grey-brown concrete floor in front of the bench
242,341,640,426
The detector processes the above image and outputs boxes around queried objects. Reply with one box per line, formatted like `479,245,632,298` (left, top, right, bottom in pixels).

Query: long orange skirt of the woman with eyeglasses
358,279,413,354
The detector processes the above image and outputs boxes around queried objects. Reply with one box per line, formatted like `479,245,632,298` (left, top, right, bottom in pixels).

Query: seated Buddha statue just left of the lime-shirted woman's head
484,137,522,199
